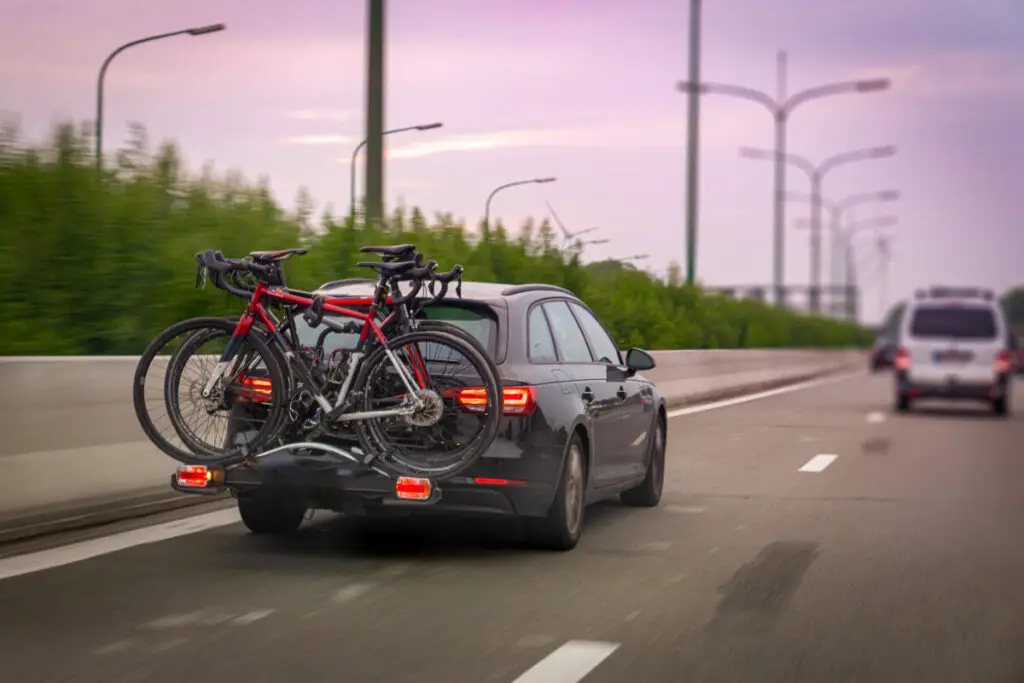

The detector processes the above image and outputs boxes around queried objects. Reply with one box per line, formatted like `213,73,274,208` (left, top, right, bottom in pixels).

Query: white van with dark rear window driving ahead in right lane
893,287,1015,415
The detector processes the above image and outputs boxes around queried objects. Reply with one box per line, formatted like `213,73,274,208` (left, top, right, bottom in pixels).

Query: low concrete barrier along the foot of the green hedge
0,349,864,538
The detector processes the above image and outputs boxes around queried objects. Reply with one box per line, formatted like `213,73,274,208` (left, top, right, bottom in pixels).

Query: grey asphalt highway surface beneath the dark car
0,376,1024,683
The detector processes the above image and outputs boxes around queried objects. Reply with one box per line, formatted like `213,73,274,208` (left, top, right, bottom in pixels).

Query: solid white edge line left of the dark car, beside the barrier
0,509,239,580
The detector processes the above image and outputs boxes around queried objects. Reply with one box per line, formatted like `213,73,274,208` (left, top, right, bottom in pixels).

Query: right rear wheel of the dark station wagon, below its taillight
525,434,587,552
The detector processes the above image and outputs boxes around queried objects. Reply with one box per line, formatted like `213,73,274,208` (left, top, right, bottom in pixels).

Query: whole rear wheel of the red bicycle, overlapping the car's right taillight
353,330,502,478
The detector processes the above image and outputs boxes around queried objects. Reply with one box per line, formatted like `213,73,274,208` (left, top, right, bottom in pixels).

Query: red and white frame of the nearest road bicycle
203,283,425,422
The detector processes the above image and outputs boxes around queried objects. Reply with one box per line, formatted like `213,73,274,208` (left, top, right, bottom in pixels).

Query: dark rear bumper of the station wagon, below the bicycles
171,452,555,517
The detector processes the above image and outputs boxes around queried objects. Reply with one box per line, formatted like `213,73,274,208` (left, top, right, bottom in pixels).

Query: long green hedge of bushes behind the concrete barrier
0,125,871,355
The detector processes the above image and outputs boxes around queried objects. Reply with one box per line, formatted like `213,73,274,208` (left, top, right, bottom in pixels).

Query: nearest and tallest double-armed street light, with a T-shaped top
677,50,892,304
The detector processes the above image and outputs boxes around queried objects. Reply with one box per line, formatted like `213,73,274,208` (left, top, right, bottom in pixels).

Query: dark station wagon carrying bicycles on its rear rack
228,281,668,550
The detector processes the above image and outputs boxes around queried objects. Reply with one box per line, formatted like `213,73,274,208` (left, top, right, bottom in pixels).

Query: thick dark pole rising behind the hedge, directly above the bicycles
365,0,384,225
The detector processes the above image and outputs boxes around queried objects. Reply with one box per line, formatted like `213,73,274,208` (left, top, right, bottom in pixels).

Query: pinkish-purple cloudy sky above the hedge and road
0,0,1024,319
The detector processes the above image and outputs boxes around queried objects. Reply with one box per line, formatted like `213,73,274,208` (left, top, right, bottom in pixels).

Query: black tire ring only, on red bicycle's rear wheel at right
352,330,502,479
